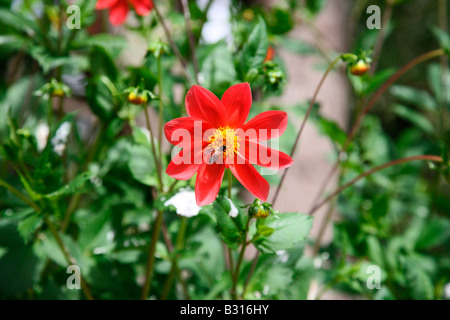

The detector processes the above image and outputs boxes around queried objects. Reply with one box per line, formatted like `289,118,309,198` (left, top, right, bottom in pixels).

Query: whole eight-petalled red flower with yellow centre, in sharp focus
164,83,293,206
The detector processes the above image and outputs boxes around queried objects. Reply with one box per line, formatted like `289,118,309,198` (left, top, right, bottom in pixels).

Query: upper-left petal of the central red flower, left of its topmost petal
185,85,227,128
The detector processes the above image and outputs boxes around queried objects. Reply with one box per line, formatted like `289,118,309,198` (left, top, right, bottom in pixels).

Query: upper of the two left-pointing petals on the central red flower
164,117,211,148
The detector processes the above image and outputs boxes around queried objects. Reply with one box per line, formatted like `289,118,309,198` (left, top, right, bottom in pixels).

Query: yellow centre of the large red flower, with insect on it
205,127,240,164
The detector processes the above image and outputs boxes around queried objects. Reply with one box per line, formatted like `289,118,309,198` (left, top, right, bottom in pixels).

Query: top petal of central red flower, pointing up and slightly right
222,82,252,128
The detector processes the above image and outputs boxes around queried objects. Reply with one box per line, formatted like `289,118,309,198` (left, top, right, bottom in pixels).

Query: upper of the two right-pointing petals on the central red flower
242,110,287,141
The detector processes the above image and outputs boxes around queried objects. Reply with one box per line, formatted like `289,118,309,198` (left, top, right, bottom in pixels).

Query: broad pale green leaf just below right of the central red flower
255,212,313,253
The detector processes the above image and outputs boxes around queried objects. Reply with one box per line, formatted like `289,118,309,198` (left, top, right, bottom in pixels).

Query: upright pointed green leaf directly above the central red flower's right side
241,17,269,79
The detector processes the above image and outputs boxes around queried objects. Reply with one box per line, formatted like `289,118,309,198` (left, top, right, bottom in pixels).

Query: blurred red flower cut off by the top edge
95,0,153,25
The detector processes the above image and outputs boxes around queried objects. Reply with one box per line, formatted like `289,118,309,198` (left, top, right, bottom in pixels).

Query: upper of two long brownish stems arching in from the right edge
310,49,445,212
